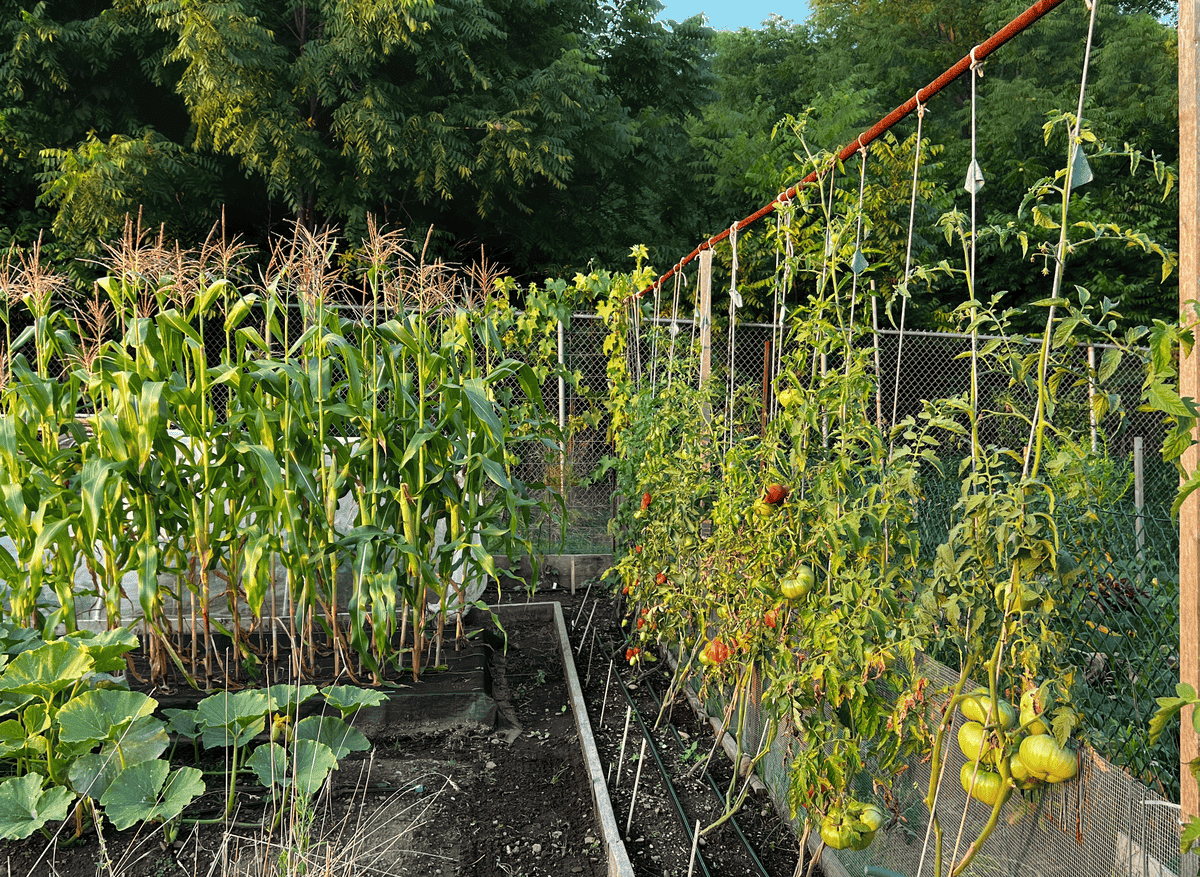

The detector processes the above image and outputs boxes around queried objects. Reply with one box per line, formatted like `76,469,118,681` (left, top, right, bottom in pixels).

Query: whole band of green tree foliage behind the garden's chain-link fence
0,0,1177,324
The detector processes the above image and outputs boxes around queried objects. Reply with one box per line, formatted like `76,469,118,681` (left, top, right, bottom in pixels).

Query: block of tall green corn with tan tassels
0,219,559,687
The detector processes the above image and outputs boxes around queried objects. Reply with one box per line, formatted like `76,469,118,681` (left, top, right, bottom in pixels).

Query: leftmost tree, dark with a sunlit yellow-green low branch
0,2,217,256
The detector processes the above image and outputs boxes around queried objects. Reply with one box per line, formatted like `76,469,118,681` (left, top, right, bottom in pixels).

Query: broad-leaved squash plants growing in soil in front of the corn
0,629,384,840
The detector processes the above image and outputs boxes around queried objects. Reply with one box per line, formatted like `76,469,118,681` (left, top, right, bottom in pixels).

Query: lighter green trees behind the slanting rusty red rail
692,0,1177,330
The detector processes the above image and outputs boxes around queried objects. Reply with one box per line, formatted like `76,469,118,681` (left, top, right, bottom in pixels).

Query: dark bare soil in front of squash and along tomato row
0,575,811,877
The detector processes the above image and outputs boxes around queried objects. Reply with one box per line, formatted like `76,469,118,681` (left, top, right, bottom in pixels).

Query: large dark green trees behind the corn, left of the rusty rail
0,0,712,278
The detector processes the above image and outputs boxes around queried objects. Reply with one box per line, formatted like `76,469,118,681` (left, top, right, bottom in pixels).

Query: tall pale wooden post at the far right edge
1178,0,1200,819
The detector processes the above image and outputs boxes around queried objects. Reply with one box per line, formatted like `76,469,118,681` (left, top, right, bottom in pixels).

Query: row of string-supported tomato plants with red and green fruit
595,127,1185,877
